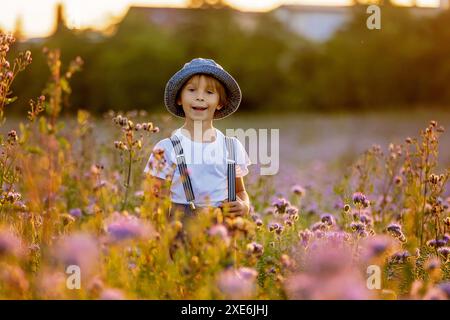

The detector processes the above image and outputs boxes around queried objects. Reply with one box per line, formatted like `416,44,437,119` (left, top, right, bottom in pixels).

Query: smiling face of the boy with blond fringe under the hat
177,75,222,121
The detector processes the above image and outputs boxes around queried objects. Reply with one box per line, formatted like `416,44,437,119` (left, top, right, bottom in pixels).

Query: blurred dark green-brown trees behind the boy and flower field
3,1,450,114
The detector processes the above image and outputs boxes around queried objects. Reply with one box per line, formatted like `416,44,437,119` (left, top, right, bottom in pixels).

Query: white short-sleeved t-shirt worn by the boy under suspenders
144,129,251,207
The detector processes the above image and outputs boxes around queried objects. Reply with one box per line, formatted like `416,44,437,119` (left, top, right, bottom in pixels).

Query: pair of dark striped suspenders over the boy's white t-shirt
170,135,236,210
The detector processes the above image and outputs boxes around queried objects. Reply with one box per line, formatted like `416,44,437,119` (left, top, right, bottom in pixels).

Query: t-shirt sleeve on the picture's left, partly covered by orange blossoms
144,139,175,180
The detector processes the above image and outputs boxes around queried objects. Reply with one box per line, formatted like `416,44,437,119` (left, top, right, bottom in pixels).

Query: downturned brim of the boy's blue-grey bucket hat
164,65,242,120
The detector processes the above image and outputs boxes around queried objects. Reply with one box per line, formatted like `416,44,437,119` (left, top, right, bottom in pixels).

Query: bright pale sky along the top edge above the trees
0,0,439,37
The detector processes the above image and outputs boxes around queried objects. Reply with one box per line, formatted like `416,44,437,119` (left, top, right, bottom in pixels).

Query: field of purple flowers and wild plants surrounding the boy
0,35,450,299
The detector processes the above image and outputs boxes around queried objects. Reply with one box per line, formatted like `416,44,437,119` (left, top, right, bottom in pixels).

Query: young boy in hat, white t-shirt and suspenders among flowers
144,58,250,215
